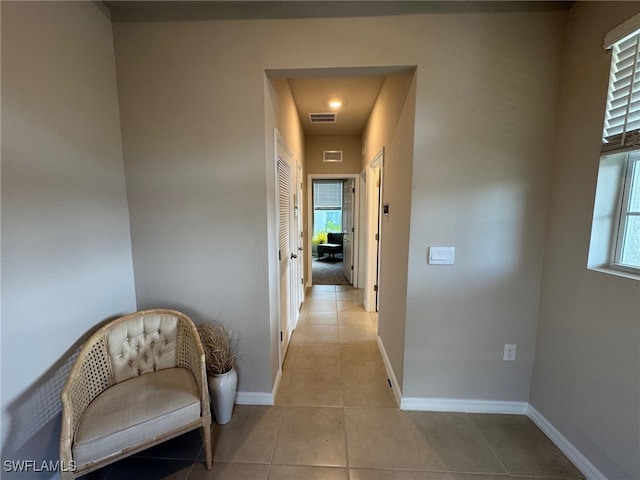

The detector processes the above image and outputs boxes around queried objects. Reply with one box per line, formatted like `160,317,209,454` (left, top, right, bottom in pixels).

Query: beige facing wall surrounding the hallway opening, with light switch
114,12,563,400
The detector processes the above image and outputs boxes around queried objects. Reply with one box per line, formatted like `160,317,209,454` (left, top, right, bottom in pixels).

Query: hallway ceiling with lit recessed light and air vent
288,75,385,135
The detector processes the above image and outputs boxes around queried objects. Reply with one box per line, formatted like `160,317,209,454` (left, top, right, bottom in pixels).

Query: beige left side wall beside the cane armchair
0,2,136,462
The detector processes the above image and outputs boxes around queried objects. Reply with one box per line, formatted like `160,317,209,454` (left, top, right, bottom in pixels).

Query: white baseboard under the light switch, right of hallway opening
400,397,529,415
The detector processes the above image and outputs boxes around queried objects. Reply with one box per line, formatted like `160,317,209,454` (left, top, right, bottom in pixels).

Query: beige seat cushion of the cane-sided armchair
73,368,200,465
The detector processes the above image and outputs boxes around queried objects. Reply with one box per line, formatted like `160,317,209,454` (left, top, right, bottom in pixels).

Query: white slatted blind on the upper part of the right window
602,31,640,152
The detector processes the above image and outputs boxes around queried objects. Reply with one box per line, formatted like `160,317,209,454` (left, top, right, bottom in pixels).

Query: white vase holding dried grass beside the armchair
198,320,238,425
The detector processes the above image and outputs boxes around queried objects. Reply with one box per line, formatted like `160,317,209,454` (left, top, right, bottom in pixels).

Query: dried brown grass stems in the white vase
198,320,236,375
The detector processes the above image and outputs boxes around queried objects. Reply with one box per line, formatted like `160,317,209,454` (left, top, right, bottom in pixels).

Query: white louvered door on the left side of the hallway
276,136,297,362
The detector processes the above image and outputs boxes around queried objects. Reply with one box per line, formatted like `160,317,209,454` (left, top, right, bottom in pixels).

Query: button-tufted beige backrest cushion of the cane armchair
107,314,178,383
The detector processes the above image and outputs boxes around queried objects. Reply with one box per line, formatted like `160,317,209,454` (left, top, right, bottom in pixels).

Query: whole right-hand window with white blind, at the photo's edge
589,15,640,274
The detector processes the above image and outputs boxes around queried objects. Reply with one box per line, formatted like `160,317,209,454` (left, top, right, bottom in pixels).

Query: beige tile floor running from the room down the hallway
81,285,583,480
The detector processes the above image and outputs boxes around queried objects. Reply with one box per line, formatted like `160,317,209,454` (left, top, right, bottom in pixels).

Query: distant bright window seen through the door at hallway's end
313,180,342,243
